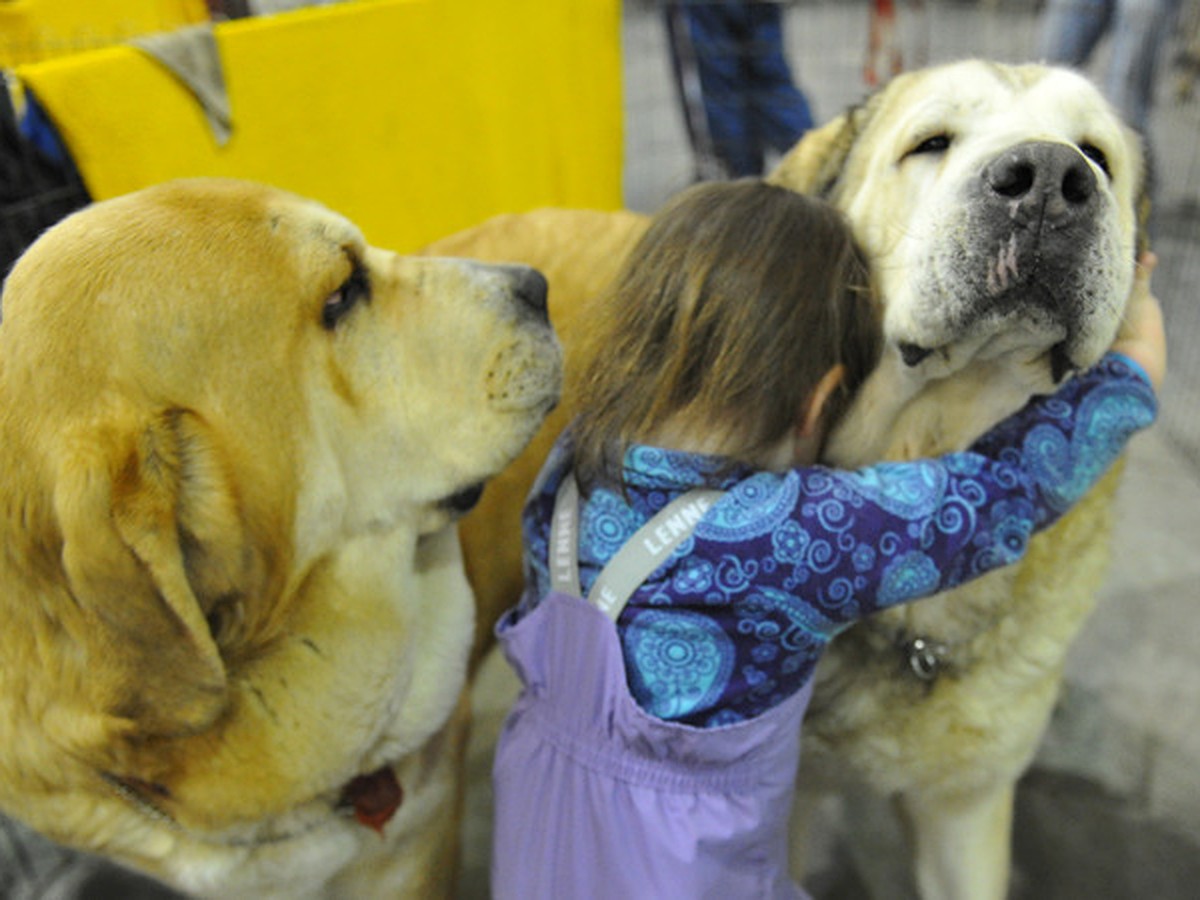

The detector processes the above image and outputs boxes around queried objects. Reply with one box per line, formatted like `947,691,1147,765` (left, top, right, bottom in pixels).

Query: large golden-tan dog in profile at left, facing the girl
0,180,562,898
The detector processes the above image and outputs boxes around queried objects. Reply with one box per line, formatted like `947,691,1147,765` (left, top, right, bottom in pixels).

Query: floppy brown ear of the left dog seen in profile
54,412,246,736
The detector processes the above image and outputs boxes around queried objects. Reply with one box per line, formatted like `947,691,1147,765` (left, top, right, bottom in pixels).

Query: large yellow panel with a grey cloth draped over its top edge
18,0,622,251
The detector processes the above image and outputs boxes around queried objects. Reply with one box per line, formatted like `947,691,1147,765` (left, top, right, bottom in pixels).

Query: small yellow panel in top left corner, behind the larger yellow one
0,0,209,68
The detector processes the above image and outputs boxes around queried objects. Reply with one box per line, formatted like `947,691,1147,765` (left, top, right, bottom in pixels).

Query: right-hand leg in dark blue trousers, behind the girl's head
744,2,812,160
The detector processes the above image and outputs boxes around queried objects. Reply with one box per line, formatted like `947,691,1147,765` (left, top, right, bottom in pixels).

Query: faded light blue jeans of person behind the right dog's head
1039,0,1180,134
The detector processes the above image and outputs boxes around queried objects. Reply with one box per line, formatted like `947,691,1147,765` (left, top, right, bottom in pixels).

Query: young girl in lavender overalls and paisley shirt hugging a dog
492,181,1165,900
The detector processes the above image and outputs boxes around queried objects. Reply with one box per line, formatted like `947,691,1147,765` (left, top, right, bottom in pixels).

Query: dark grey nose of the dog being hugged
983,140,1097,221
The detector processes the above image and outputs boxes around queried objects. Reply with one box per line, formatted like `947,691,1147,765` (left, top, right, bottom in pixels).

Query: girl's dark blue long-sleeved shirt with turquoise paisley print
522,354,1157,727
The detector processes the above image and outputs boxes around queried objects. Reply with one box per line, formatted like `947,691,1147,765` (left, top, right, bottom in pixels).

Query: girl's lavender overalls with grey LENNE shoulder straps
492,480,812,900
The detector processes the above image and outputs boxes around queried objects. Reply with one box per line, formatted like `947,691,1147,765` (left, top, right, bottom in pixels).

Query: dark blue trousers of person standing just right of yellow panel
666,2,812,178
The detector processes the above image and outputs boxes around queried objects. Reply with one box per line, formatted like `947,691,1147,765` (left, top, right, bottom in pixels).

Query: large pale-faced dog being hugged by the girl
438,61,1144,900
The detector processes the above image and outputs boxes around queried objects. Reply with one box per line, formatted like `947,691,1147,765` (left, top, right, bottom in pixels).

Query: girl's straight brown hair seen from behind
572,180,881,485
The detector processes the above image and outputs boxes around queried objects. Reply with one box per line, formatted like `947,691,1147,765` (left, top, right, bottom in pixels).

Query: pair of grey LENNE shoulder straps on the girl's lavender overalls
550,474,724,622
